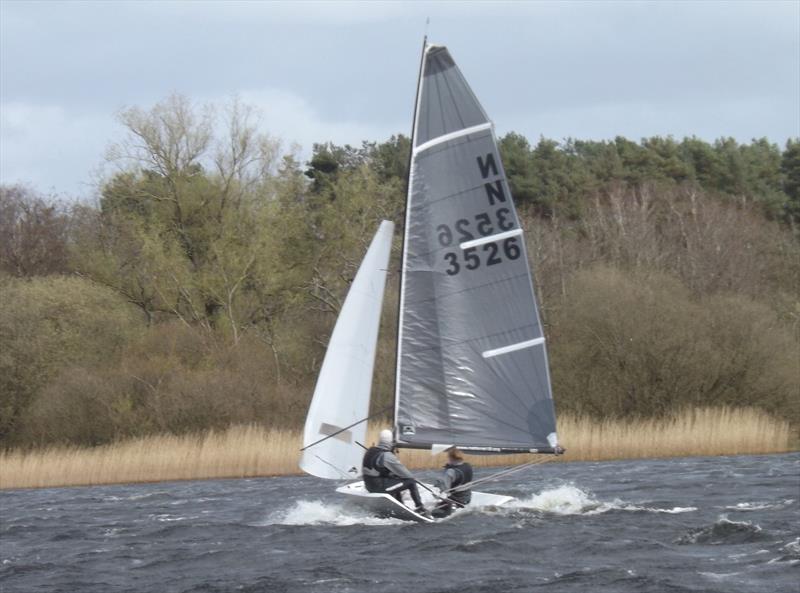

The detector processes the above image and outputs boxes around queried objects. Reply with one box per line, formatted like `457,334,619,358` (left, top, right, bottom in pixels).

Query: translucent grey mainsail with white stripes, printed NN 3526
395,46,557,452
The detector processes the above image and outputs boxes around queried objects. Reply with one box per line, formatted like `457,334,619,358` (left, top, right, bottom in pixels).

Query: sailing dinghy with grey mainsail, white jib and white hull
300,43,563,522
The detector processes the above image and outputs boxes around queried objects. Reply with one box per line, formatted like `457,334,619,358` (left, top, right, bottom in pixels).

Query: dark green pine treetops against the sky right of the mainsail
500,133,800,223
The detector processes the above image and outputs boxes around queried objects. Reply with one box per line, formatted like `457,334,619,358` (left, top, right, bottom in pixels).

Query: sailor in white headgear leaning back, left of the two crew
361,429,430,517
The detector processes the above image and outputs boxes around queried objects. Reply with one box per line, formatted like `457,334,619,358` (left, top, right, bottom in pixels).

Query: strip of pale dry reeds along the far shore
0,408,791,488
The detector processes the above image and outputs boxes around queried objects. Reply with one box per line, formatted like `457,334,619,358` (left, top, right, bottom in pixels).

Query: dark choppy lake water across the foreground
0,454,800,593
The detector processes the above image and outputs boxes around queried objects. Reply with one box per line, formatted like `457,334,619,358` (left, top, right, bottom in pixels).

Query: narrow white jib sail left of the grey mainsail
300,220,394,480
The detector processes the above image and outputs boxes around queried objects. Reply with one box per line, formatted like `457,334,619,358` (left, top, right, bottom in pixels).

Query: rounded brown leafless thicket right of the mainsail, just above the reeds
551,267,800,423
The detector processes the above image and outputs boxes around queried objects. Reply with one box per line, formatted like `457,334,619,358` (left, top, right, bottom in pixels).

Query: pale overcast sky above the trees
0,0,800,197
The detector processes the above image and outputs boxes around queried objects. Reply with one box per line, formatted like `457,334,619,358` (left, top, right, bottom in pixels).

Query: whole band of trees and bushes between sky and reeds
0,97,800,447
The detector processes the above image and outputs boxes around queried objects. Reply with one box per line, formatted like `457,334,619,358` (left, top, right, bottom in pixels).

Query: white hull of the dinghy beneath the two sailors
336,482,513,523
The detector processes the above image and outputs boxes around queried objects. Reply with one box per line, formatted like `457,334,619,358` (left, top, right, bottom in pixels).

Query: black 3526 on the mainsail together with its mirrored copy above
436,208,522,276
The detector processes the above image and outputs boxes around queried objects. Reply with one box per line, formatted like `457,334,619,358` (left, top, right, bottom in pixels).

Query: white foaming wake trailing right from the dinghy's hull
503,485,697,515
